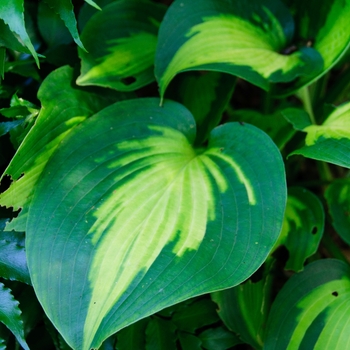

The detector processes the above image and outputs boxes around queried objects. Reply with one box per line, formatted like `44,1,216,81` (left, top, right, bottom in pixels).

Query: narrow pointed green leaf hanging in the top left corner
0,0,39,66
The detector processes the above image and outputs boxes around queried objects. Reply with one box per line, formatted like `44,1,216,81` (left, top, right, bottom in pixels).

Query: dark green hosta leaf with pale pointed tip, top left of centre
77,0,165,91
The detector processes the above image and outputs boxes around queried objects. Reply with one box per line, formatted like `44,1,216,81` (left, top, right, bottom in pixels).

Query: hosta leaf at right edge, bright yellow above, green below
291,102,350,168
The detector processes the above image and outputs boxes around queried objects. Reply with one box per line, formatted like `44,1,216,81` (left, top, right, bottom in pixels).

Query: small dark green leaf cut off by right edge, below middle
325,182,350,244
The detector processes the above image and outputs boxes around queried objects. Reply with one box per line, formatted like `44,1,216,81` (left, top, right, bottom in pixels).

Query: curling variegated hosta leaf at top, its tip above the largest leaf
155,0,323,96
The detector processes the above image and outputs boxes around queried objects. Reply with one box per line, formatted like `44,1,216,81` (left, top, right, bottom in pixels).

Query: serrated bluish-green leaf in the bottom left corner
0,282,29,350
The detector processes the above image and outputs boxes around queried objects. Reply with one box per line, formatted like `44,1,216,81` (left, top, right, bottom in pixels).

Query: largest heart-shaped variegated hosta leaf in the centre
26,99,286,350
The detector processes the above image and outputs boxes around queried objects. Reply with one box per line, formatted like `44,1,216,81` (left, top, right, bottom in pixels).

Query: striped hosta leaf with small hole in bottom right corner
264,260,350,350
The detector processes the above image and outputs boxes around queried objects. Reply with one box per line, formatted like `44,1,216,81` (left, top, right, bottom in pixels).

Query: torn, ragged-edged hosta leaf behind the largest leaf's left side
0,67,127,231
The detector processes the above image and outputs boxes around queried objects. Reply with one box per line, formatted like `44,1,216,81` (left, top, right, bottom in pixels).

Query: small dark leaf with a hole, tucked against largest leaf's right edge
275,187,325,272
